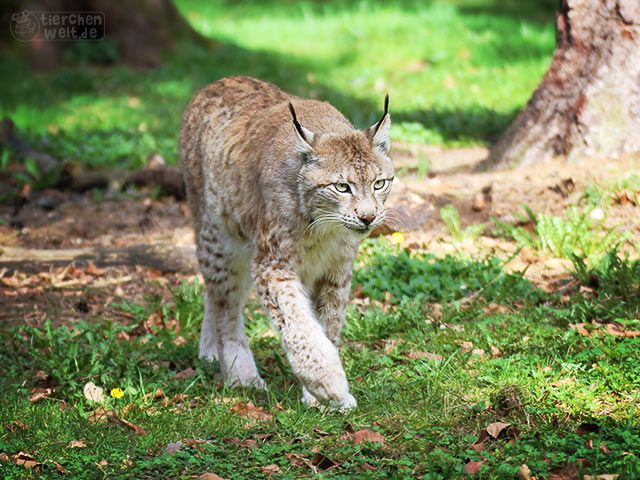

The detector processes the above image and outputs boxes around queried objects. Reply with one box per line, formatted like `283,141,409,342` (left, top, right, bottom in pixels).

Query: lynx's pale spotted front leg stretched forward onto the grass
255,262,356,409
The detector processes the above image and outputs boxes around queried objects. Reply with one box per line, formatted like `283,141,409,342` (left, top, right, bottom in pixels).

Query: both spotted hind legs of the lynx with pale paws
198,229,266,388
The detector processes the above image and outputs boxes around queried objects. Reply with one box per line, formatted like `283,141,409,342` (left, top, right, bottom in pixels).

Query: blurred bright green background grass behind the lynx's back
0,0,554,172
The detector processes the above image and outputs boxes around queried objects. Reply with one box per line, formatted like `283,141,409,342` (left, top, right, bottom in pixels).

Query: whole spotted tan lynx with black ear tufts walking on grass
179,77,394,409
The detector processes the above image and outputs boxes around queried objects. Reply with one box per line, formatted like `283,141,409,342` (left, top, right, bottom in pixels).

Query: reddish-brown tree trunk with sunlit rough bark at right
488,0,640,167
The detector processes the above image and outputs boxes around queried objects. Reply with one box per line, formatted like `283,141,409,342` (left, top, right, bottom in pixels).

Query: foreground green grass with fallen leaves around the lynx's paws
0,239,640,479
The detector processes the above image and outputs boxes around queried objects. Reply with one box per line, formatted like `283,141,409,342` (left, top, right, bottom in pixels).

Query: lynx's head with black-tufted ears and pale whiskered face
289,95,393,236
